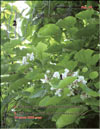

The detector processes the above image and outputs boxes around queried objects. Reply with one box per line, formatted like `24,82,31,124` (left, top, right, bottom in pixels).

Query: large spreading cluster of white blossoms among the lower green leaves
40,68,89,100
